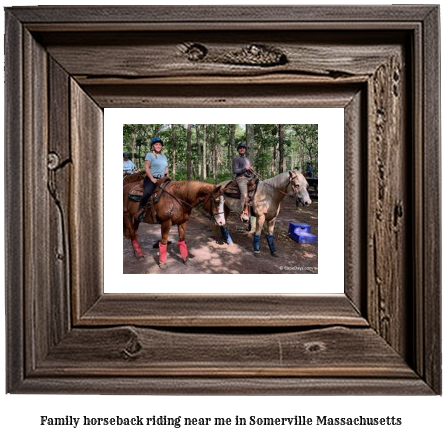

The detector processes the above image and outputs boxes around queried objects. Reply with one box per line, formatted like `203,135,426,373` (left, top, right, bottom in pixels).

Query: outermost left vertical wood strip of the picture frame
5,10,25,394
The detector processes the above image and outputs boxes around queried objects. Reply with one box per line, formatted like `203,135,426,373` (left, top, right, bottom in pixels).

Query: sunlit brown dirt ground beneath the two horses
123,196,318,274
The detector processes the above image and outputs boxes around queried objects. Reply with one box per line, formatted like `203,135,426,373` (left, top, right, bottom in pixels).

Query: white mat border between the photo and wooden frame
104,108,344,294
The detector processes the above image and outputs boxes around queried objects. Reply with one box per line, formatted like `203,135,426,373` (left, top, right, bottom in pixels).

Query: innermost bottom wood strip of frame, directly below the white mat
78,294,368,327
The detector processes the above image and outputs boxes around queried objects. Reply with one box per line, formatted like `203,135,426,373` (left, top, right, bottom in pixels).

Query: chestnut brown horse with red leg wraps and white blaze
123,178,225,267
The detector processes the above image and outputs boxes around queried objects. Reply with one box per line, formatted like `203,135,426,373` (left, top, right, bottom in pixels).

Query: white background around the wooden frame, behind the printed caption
0,0,443,438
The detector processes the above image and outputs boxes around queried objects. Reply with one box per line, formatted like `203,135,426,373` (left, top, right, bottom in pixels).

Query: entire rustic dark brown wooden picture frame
5,6,441,395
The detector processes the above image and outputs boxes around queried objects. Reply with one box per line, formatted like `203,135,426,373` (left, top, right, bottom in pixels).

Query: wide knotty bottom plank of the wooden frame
33,326,415,378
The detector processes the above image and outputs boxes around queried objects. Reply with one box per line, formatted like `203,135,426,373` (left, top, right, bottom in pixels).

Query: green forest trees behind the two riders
123,124,318,183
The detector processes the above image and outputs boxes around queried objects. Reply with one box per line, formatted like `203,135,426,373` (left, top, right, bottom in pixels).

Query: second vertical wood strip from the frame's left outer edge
22,32,50,371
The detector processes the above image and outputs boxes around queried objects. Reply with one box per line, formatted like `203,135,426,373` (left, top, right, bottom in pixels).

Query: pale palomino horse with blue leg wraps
220,170,311,257
